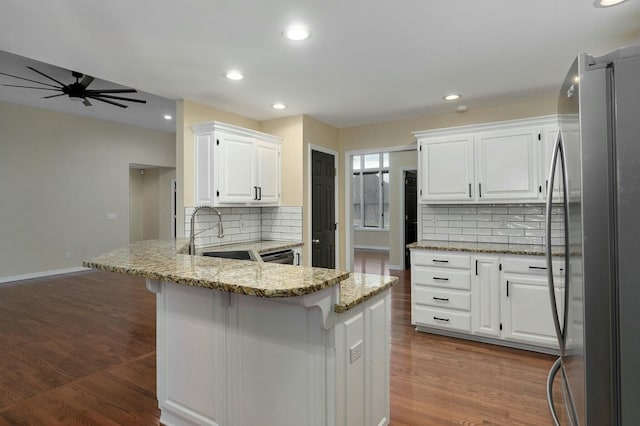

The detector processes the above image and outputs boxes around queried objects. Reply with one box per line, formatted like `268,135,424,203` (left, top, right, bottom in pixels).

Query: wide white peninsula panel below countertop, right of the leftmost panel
227,292,324,426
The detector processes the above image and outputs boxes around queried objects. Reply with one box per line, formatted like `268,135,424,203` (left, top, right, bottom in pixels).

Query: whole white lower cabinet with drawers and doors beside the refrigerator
411,249,564,352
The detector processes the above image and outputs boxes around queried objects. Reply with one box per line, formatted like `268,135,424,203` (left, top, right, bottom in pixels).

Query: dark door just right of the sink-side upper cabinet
311,151,336,268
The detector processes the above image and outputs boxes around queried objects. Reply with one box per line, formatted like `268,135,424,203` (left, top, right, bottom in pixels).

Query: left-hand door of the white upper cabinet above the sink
216,132,257,204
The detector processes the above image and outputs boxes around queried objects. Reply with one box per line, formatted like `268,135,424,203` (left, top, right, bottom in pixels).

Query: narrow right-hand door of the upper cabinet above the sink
255,141,280,204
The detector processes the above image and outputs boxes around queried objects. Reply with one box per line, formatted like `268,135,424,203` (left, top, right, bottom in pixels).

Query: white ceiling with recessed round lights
0,0,640,127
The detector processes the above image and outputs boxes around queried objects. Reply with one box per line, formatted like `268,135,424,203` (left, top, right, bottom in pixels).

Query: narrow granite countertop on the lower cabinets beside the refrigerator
407,240,564,256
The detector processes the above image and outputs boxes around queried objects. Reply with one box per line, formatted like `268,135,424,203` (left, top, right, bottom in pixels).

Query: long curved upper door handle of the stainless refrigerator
545,129,569,356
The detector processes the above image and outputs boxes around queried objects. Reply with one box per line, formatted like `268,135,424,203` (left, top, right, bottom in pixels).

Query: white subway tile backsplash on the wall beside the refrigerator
420,204,564,245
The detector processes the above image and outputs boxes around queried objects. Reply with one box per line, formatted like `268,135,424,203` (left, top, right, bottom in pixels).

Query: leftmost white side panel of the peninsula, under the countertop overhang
156,283,229,426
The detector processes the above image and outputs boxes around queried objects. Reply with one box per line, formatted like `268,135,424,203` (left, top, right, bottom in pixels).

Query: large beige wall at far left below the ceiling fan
0,103,176,277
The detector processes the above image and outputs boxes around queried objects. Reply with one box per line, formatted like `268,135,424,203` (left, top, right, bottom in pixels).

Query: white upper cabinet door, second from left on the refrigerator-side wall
476,128,539,201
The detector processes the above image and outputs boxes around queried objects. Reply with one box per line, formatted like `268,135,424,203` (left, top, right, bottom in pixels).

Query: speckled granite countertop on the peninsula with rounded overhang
83,239,398,313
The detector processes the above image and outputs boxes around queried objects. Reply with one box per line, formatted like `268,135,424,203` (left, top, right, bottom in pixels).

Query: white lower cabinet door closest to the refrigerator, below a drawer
501,274,564,348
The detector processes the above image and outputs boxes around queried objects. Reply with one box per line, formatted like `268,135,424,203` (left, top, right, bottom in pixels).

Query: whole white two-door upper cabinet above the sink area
192,122,281,206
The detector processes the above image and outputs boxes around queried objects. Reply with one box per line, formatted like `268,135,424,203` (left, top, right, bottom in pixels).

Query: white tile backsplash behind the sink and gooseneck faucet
185,206,302,246
